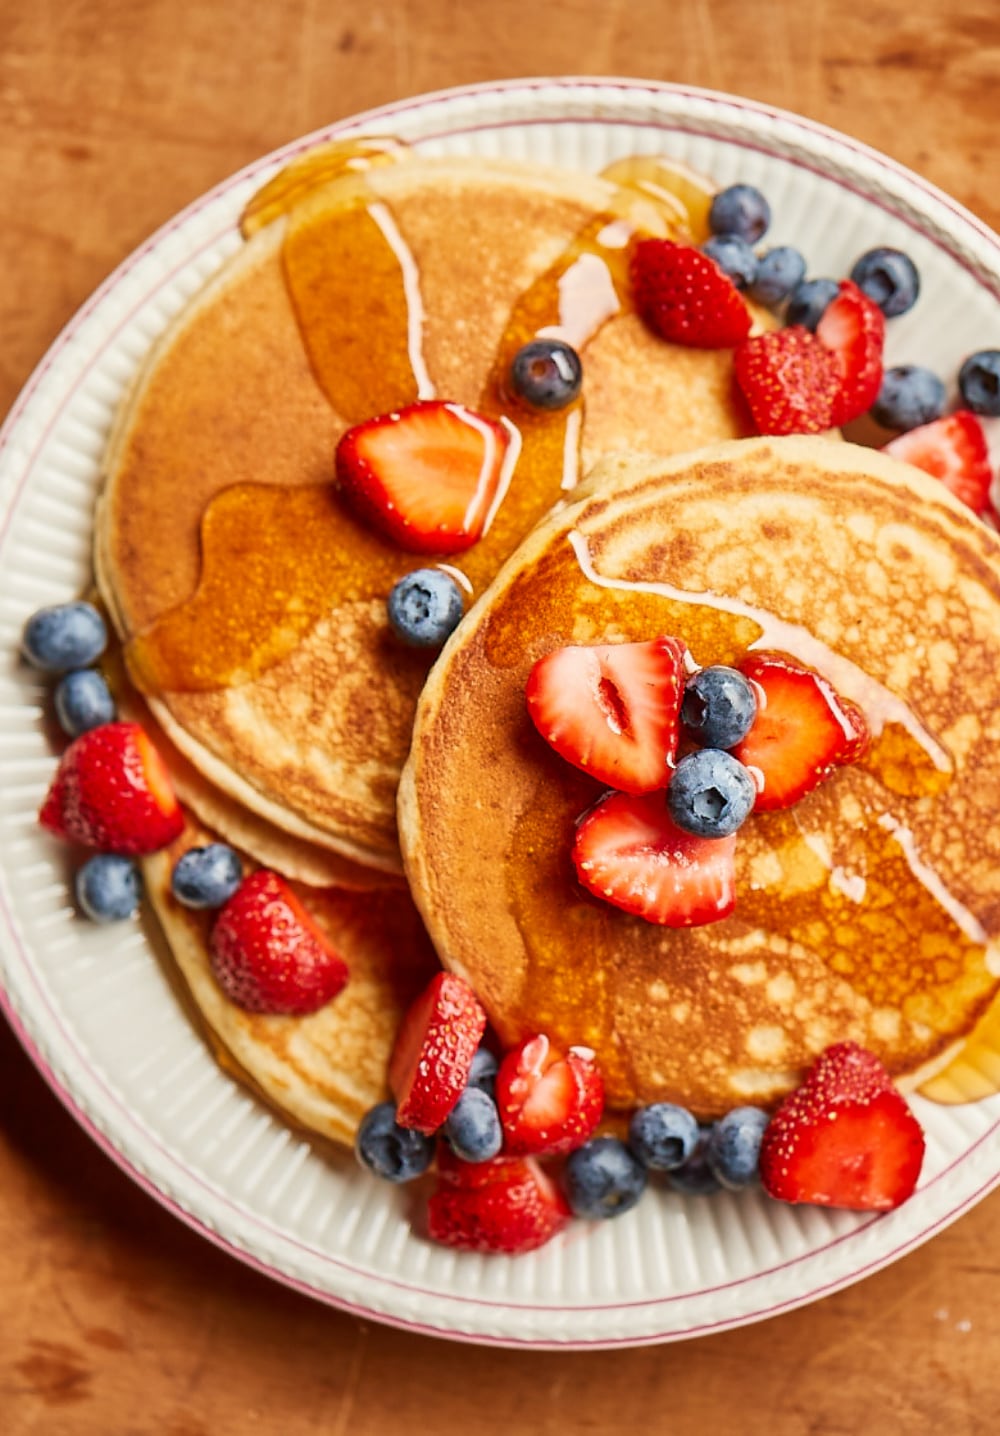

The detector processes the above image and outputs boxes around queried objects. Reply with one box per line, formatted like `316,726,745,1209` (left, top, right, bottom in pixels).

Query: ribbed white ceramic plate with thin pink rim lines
0,80,1000,1347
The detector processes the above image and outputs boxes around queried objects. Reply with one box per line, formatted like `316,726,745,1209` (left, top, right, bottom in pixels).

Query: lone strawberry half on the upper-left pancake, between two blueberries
336,399,510,553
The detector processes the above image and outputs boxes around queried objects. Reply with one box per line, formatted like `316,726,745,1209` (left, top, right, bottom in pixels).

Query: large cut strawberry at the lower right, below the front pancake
760,1043,924,1212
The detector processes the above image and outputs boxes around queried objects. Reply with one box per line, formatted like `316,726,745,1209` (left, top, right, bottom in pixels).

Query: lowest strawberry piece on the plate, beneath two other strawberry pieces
427,1159,572,1257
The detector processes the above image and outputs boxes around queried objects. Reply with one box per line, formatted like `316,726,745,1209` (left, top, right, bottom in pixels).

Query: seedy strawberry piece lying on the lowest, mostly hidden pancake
208,867,348,1017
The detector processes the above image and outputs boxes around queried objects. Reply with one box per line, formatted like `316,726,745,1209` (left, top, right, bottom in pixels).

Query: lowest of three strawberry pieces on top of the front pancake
573,793,736,928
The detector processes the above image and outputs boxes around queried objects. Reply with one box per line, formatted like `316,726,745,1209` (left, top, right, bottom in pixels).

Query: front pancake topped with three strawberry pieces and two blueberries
399,438,1000,1119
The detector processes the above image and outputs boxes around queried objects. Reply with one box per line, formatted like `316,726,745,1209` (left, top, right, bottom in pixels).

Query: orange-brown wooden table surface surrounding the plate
0,0,1000,1436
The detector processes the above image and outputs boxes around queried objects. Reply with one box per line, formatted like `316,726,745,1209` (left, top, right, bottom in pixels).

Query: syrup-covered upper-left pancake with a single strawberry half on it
96,145,770,872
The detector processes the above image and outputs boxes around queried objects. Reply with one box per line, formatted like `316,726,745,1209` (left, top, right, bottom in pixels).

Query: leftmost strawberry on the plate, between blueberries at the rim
39,722,184,857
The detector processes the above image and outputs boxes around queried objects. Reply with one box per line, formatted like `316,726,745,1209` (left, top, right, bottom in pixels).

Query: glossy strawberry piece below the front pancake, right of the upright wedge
496,1034,603,1156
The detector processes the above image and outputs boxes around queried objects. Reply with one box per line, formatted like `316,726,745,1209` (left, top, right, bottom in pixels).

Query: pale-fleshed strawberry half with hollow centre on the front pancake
524,638,687,793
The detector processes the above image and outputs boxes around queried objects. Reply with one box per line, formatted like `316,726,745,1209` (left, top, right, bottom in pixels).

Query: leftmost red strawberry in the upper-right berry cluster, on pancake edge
629,240,751,349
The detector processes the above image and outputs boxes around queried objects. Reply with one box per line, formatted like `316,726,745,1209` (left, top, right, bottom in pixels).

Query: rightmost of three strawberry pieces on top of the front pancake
733,653,868,811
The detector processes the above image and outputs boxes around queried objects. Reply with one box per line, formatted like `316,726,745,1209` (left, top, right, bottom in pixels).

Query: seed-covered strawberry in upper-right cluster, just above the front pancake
733,325,841,434
